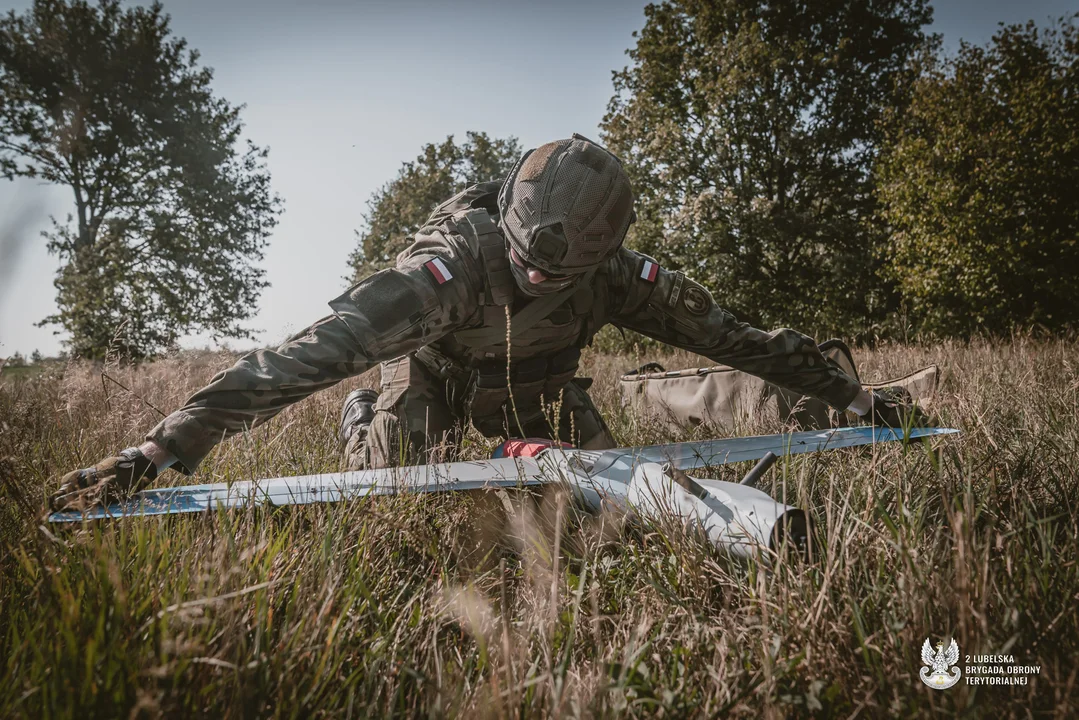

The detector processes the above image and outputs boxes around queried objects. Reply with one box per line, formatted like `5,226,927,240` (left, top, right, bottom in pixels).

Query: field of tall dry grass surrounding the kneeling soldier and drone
0,337,1079,718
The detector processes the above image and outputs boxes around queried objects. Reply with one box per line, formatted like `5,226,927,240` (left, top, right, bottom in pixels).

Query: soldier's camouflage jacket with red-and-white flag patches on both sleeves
148,184,860,472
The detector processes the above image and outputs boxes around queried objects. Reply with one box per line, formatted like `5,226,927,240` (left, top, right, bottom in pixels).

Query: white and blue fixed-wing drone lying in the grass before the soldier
49,426,959,558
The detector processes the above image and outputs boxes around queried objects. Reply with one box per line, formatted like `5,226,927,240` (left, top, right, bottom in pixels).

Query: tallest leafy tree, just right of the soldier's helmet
602,0,931,332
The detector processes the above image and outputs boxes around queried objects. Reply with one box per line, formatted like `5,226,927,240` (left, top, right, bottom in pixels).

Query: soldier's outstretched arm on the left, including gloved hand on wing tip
52,252,477,507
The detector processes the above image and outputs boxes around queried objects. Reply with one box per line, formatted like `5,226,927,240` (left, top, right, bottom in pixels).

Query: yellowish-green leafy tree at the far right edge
878,15,1079,335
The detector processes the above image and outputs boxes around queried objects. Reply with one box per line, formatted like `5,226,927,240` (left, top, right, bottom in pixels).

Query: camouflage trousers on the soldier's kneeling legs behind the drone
345,355,615,470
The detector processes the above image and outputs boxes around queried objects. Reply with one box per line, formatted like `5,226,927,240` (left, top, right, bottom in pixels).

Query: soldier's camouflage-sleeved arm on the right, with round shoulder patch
611,250,865,411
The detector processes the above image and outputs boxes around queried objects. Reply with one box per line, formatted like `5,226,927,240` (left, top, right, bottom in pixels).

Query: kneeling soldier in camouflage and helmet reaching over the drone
52,135,909,507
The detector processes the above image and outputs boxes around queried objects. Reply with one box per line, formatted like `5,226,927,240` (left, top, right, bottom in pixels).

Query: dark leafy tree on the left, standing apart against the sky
0,0,281,357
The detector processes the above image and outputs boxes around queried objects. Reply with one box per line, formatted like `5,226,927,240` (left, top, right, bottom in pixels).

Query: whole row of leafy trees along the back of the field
0,0,1079,356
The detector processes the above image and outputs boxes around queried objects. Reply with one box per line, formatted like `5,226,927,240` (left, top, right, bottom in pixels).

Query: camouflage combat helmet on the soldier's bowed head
498,134,637,277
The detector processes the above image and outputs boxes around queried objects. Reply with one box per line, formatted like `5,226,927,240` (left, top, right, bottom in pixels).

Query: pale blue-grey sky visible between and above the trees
0,0,1079,357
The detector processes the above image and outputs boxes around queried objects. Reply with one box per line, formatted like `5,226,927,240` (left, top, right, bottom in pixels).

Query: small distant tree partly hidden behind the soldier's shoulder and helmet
349,132,521,281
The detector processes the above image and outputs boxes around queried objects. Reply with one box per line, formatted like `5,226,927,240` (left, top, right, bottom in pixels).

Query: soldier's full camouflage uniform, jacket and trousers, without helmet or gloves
149,184,860,472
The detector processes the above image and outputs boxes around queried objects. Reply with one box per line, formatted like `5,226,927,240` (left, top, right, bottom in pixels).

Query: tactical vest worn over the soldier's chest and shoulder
415,182,606,435
